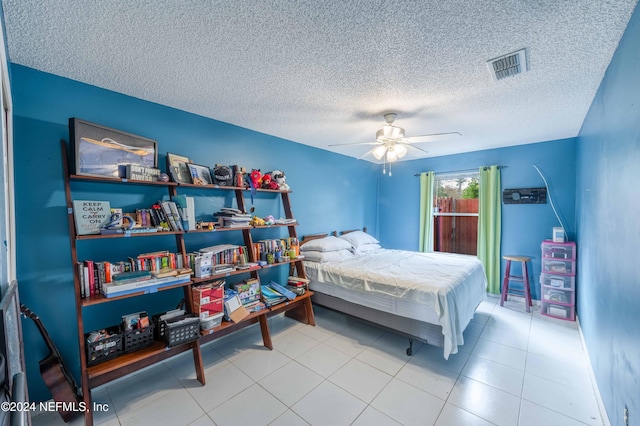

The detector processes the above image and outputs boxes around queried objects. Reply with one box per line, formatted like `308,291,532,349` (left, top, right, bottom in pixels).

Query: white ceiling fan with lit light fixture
329,112,462,176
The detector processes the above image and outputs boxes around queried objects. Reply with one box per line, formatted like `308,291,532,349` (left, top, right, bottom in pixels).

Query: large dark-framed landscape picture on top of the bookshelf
69,118,158,179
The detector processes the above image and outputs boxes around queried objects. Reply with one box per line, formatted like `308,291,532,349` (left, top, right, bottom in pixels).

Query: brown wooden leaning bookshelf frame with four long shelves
61,140,315,425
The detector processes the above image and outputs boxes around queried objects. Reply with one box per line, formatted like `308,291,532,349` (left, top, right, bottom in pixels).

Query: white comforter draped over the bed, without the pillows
306,249,487,358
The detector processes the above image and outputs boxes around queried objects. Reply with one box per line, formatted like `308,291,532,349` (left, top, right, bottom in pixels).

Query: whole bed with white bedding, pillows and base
300,230,487,359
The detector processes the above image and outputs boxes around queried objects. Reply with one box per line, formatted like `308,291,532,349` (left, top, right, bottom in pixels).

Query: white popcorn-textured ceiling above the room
2,0,637,161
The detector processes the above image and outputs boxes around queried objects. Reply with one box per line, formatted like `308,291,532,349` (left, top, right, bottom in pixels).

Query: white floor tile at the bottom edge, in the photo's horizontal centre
291,381,367,426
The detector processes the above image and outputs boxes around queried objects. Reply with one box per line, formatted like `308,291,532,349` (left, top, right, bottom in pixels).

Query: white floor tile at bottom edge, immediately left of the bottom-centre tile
208,384,287,426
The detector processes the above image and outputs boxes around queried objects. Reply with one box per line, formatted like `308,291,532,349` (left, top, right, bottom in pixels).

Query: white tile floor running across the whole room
32,297,605,426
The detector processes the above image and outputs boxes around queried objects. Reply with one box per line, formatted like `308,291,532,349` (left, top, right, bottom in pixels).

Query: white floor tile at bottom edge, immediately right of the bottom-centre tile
371,379,444,425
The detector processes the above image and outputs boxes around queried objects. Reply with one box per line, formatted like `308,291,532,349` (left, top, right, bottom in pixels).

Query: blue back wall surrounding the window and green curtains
378,139,576,299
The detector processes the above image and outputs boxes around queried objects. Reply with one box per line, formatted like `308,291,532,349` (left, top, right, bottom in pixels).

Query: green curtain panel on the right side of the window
478,166,502,294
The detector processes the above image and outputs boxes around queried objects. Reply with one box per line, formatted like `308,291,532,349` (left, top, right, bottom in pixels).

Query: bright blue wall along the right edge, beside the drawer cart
576,2,640,425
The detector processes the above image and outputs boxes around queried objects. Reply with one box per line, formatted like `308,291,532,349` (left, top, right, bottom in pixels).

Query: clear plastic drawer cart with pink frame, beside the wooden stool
540,240,576,321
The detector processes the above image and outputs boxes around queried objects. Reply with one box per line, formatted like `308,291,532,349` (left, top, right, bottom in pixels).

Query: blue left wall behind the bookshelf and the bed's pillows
11,65,378,401
